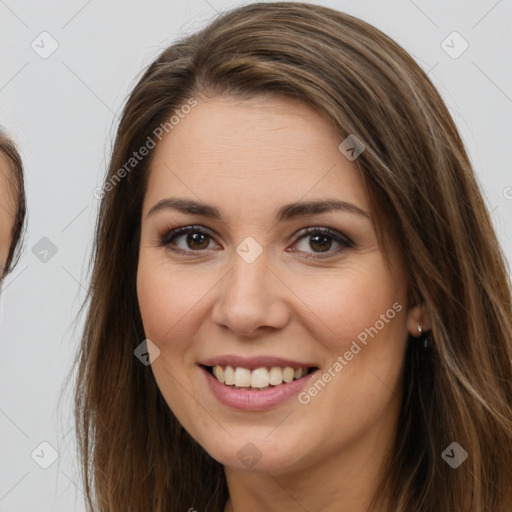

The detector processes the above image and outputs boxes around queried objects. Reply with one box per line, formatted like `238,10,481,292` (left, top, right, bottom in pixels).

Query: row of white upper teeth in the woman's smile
212,365,308,389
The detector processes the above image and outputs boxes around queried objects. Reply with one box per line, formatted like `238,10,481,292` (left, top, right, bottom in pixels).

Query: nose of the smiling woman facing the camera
212,251,291,337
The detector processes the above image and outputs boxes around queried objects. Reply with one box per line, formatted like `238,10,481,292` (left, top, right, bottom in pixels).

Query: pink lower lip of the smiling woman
200,366,317,411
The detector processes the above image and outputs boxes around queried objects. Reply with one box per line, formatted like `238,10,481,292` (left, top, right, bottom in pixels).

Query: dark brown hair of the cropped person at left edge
0,129,27,281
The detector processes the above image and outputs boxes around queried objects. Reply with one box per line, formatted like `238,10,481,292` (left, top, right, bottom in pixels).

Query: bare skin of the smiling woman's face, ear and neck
137,96,429,512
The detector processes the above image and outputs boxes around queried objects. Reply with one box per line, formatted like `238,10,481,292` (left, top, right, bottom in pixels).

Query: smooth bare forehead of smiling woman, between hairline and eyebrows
145,97,369,220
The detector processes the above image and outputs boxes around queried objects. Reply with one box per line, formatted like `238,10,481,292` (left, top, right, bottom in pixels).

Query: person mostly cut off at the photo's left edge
0,131,26,282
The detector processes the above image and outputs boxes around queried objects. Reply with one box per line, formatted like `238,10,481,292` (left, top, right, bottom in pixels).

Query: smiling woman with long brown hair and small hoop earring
76,2,512,512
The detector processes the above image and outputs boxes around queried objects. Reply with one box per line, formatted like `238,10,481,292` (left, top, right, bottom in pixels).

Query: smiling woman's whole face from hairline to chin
137,97,419,474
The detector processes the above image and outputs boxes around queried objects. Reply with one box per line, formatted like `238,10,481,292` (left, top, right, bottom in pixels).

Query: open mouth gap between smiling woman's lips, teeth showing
200,365,318,392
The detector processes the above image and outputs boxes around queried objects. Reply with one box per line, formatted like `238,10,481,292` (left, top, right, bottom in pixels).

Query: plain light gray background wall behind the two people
0,0,512,512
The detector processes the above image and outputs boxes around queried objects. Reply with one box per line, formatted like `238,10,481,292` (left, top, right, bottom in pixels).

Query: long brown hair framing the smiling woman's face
75,2,512,512
